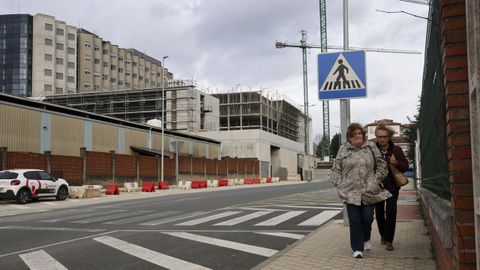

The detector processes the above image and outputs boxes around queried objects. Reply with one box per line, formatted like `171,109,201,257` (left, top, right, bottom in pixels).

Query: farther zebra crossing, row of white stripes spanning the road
30,205,342,228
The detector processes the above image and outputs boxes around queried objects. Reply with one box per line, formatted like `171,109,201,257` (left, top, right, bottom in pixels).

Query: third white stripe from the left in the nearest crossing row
164,232,278,257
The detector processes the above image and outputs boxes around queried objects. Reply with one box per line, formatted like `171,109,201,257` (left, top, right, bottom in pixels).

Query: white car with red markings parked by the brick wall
0,169,68,204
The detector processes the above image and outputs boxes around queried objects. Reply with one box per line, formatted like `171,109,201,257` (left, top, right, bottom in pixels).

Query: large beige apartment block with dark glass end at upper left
0,14,173,97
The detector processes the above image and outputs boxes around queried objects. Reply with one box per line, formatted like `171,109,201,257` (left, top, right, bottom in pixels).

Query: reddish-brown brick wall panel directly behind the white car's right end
50,155,83,186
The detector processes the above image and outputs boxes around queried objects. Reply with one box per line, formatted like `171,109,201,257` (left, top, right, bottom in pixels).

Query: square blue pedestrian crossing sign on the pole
318,51,367,100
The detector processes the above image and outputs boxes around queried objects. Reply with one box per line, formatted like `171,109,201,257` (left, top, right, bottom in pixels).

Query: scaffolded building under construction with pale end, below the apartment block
44,80,219,132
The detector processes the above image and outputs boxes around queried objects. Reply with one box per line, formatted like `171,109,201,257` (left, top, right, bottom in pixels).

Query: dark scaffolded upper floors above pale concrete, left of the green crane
213,91,304,142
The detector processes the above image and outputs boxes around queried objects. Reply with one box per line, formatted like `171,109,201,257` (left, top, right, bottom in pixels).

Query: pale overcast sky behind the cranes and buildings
0,0,428,137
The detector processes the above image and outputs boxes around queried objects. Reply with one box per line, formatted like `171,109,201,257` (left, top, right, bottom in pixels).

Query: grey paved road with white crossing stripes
0,182,341,269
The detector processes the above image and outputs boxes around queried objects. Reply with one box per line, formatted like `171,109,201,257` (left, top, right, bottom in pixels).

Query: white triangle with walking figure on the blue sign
320,53,365,91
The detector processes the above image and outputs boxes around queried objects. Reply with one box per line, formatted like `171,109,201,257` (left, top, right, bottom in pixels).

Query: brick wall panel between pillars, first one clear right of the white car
86,151,112,180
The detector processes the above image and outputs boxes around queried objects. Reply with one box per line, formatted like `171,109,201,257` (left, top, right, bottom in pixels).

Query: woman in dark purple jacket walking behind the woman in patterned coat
375,123,408,250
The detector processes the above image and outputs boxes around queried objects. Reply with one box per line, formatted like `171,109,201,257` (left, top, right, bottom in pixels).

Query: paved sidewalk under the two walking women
254,179,436,270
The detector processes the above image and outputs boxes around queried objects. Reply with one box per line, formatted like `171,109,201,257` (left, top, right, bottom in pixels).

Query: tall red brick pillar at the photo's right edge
436,0,476,269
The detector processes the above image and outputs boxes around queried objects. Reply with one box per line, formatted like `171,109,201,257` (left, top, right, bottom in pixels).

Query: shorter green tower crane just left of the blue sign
275,30,318,155
